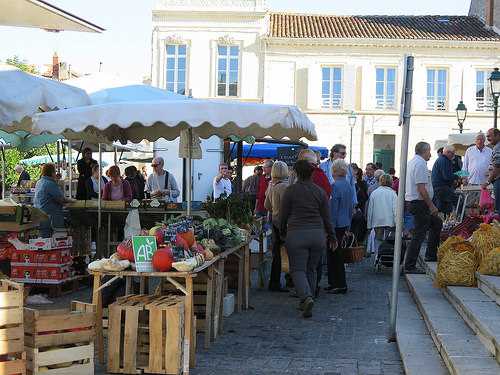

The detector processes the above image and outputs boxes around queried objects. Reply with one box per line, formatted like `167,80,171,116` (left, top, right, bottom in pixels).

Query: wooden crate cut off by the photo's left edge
0,279,26,375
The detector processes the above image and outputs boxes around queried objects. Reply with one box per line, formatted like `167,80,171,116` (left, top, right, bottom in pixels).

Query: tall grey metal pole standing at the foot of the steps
389,56,414,341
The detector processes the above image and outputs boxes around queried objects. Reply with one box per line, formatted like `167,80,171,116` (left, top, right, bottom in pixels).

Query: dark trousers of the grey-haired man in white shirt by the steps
405,200,443,269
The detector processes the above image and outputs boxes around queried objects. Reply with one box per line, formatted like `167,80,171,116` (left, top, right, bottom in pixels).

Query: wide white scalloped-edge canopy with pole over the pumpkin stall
32,99,317,214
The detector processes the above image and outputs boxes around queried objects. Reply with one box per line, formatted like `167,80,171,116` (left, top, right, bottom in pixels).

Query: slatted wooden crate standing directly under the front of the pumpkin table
107,295,184,374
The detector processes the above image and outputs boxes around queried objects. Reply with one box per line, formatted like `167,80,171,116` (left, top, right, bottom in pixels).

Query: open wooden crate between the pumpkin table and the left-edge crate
24,302,96,375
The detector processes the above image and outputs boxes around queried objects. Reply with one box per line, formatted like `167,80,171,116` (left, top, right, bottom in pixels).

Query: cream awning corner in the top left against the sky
0,0,104,33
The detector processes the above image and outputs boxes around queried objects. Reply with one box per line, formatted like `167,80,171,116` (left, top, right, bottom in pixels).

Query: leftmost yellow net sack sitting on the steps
436,241,478,288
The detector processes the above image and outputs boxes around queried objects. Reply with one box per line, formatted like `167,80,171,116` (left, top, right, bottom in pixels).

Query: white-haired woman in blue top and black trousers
325,159,354,294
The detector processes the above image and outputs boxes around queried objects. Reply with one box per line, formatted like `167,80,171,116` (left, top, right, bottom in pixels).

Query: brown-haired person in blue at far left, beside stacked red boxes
34,164,73,238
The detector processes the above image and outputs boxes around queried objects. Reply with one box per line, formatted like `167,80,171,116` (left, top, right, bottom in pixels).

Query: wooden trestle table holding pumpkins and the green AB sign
89,242,250,374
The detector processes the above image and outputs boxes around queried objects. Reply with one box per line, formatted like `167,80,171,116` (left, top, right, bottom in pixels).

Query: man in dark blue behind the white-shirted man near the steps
432,146,458,215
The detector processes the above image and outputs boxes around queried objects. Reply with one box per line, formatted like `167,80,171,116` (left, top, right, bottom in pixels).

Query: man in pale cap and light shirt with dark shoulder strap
146,157,180,202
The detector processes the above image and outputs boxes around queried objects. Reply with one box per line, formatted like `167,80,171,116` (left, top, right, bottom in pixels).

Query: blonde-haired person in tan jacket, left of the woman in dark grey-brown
264,161,288,292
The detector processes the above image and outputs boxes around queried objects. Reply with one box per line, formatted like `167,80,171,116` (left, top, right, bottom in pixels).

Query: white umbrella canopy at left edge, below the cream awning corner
0,64,91,129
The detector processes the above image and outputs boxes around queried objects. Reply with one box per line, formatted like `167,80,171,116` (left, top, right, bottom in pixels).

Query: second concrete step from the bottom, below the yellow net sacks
405,275,500,375
